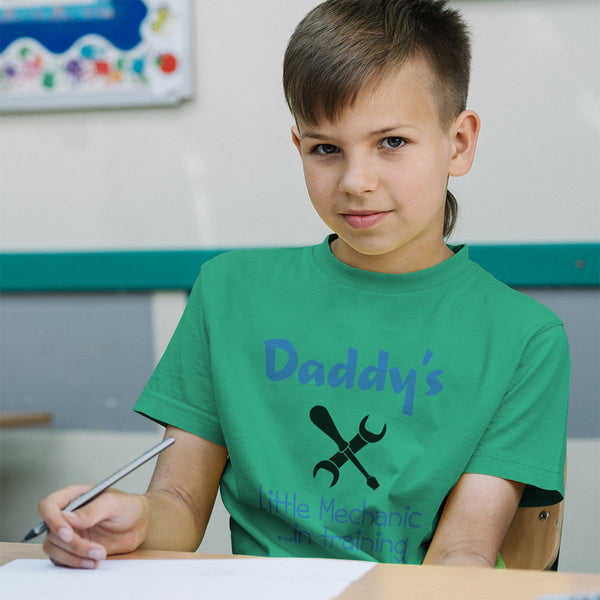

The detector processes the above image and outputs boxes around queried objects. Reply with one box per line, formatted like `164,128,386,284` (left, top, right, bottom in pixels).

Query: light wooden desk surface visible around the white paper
0,542,600,600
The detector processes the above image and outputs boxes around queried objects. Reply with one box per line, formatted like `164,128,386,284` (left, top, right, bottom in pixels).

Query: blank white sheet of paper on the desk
0,558,374,600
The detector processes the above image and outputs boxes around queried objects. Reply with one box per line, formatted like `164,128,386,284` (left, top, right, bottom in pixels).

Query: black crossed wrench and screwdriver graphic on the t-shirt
310,406,387,490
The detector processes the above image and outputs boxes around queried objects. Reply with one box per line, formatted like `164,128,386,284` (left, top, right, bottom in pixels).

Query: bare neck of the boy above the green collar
330,235,454,274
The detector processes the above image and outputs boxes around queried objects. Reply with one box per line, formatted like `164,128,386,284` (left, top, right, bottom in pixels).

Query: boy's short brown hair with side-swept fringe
283,0,471,236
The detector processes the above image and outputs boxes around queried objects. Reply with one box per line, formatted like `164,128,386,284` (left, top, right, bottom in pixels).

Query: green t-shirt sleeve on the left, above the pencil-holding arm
134,273,225,446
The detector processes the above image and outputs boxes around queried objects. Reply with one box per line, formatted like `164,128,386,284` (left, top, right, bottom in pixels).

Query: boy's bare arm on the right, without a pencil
423,473,525,567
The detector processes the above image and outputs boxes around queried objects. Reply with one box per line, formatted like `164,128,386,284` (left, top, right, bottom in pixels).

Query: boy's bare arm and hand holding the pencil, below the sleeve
39,427,227,568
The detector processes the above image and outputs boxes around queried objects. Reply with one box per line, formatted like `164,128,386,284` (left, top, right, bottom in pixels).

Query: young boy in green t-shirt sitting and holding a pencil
40,0,569,568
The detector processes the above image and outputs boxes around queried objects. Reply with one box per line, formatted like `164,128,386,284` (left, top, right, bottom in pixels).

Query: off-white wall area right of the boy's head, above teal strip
453,0,600,243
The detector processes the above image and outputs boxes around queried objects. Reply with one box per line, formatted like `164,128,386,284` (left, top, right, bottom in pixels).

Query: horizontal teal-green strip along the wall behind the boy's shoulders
0,243,600,292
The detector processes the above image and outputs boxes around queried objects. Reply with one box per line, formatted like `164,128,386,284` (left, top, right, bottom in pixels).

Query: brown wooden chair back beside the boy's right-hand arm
500,464,567,571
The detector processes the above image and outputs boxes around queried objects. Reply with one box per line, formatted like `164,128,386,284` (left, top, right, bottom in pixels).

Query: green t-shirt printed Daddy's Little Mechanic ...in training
136,240,570,563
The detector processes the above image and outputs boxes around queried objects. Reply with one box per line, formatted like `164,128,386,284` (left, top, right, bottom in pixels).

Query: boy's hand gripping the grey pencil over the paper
38,485,149,569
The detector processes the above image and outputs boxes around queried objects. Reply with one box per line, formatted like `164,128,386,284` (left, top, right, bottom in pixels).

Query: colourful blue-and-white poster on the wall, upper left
0,0,193,112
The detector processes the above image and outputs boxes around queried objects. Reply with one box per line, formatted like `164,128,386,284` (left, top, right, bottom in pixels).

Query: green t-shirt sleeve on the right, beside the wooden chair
465,324,571,506
